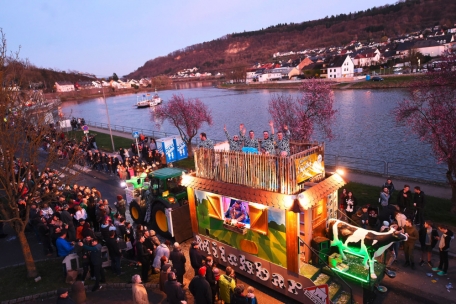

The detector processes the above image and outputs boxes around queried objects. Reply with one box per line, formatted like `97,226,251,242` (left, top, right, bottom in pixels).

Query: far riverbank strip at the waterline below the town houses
217,75,423,90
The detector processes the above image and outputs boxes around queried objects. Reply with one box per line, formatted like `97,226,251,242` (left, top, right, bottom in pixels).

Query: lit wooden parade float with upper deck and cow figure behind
182,143,400,303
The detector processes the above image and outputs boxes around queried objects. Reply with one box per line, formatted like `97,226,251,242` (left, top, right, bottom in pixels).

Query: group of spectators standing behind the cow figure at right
340,178,454,276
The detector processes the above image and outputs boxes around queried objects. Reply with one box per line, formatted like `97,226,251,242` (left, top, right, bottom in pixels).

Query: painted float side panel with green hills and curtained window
195,190,287,268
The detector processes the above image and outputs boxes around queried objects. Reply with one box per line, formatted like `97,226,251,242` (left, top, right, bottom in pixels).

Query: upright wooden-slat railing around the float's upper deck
194,142,324,194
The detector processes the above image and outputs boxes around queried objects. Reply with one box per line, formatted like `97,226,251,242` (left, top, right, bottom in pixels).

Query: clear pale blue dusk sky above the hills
0,0,395,76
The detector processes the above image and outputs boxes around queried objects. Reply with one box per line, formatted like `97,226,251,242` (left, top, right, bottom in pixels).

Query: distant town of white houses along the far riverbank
37,24,450,92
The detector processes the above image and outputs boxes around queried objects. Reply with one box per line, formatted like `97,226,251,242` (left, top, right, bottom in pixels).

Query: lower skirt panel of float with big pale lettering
195,235,315,304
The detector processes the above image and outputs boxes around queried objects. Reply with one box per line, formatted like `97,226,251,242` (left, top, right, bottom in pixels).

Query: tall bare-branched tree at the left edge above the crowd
0,29,78,277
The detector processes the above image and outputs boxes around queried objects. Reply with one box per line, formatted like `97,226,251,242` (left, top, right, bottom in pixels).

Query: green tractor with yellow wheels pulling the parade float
126,168,193,242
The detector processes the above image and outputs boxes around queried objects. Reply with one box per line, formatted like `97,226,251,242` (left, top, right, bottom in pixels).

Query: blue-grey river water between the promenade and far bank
62,83,445,182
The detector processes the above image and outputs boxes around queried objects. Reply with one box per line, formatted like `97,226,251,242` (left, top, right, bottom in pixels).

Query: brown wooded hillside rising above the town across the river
125,0,456,79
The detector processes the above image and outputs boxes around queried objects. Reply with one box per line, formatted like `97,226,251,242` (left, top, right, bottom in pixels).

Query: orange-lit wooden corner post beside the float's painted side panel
285,210,299,273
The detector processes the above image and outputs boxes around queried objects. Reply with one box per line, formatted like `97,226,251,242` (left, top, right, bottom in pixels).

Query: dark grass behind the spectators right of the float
339,182,456,226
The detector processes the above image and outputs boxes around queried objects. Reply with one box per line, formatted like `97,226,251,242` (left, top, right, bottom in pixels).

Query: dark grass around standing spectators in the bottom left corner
0,259,159,301
